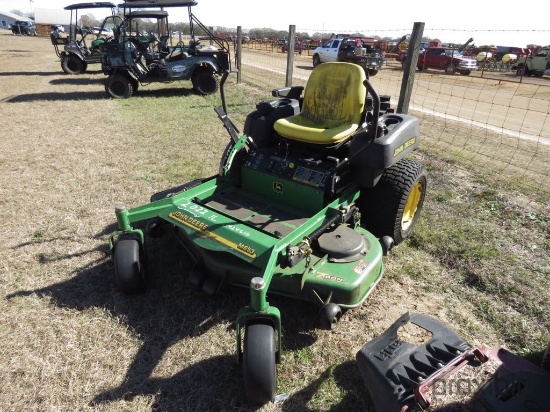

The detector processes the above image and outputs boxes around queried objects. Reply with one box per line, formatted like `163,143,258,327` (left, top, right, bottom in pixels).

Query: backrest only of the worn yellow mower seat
301,62,366,129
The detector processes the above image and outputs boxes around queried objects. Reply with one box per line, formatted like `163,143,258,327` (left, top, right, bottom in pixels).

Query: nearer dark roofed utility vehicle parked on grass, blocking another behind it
101,0,231,98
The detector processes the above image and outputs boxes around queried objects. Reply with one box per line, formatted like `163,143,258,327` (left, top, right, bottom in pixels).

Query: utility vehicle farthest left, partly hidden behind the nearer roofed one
50,2,116,74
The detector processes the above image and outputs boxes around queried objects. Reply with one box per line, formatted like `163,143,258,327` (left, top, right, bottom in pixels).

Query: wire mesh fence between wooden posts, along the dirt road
232,29,550,196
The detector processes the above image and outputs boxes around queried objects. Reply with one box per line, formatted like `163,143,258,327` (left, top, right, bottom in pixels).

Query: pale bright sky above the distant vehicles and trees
0,0,550,47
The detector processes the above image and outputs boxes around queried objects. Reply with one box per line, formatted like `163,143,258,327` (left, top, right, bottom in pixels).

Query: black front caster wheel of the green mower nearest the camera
243,323,277,404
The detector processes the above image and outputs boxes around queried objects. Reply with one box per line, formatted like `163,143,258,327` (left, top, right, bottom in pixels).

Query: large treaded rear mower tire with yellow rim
358,159,428,246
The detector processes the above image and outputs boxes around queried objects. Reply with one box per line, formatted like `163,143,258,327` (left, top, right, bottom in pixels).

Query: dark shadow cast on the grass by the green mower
6,226,360,411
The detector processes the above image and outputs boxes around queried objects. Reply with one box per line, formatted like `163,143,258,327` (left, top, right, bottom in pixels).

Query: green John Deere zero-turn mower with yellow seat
109,62,427,403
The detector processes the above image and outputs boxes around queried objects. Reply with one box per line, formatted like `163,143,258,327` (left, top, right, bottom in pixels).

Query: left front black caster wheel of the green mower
113,239,145,295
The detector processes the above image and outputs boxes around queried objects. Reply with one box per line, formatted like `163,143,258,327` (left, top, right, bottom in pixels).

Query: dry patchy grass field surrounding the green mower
0,35,550,412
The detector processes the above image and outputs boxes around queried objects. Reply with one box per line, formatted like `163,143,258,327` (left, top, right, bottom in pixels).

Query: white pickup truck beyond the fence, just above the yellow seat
313,37,386,76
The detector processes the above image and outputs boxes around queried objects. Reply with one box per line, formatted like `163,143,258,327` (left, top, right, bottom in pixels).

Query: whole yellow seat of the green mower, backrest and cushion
274,62,366,145
